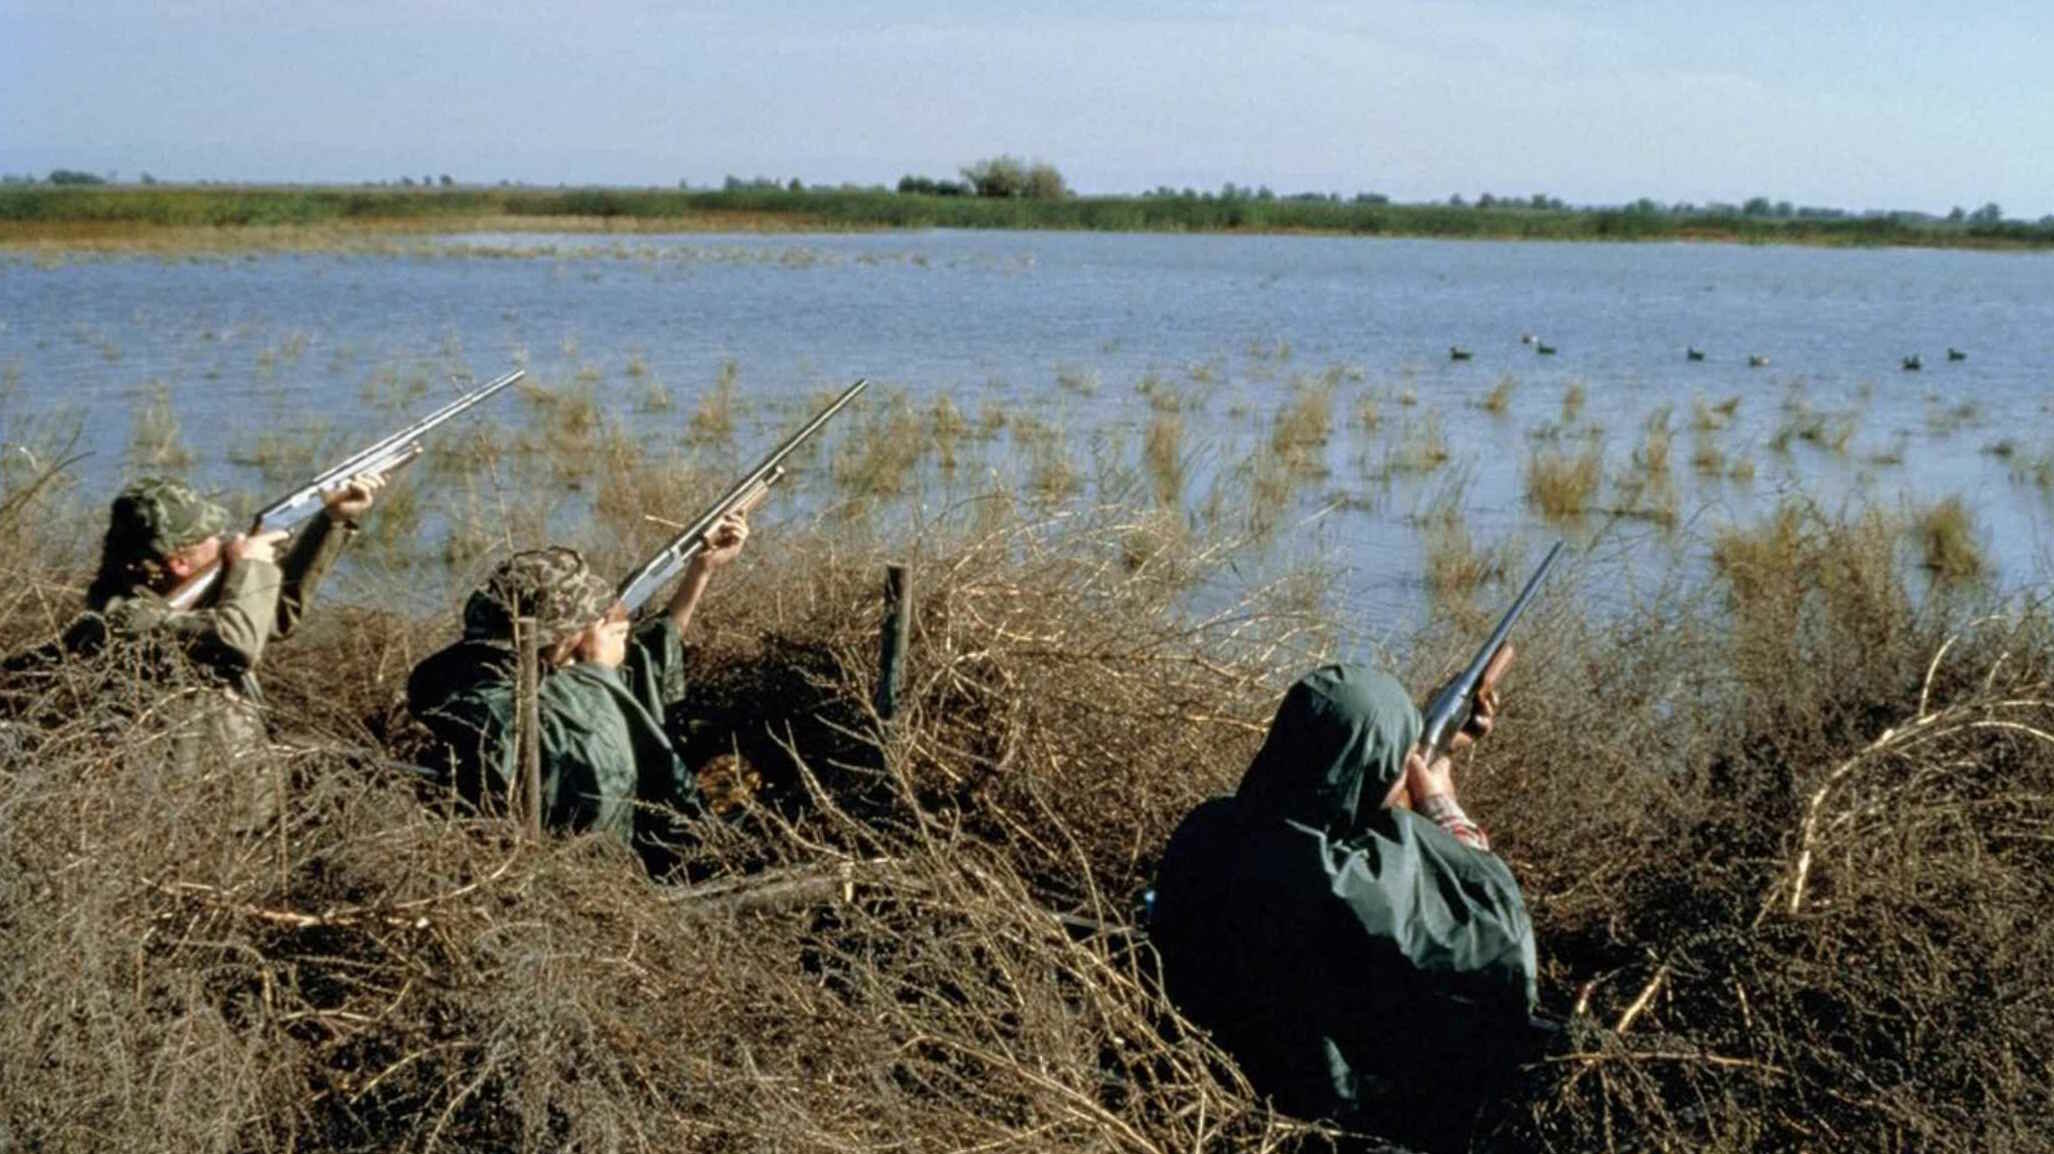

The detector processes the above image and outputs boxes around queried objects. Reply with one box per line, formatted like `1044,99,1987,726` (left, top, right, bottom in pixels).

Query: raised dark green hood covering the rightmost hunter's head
1234,665,1419,838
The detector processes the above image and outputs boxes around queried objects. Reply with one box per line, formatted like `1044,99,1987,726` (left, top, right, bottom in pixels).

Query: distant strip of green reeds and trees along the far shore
0,177,2054,246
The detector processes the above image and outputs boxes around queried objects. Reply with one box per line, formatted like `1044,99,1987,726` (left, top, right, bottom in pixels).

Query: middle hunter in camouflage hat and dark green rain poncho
407,507,750,858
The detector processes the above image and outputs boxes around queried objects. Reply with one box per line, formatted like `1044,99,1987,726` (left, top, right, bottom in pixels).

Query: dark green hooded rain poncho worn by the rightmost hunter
1150,665,1536,1121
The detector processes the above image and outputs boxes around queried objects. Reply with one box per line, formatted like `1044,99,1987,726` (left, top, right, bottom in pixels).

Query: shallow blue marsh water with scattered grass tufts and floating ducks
0,232,2054,618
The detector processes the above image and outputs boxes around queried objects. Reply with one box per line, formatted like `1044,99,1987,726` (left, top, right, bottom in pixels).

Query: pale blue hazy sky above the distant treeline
0,0,2054,220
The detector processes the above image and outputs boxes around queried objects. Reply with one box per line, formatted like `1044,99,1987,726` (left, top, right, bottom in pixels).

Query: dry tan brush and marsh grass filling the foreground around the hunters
0,375,2054,1154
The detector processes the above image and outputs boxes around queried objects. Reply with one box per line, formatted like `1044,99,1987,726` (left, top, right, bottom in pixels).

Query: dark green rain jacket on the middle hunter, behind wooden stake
407,614,698,844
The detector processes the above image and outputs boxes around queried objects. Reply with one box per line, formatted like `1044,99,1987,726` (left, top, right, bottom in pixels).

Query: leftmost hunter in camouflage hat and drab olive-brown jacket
62,474,384,830
